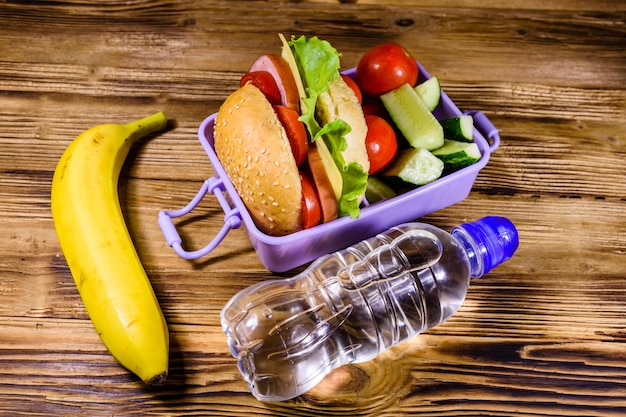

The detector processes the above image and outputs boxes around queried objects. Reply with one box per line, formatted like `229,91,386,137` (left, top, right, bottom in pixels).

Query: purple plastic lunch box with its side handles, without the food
158,63,500,272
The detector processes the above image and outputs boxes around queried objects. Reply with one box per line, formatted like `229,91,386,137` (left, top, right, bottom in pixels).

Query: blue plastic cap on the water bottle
460,216,519,274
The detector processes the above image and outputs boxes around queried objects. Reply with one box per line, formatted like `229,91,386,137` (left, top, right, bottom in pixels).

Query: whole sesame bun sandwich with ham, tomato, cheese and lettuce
214,35,369,236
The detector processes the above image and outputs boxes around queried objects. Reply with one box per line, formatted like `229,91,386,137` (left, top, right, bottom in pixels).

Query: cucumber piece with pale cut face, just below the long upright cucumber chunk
381,148,444,185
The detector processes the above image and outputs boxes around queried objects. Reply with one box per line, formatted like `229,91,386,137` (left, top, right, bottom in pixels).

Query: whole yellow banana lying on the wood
51,112,169,385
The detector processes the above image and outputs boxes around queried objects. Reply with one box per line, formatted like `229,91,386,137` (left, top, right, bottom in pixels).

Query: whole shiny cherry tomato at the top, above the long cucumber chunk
356,42,418,97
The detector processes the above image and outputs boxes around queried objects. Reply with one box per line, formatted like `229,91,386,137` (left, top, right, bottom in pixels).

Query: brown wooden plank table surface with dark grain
0,0,626,416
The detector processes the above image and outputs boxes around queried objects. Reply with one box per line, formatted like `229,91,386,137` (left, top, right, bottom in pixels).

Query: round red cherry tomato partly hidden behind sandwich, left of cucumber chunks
365,114,398,174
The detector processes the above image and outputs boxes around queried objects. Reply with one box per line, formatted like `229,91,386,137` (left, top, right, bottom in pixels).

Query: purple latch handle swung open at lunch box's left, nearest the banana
159,177,241,260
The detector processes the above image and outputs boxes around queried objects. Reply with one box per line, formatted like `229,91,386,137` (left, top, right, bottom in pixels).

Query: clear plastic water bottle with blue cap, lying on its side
221,216,518,401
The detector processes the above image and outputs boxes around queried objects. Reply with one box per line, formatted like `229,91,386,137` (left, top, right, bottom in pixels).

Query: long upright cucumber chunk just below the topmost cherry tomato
380,84,443,150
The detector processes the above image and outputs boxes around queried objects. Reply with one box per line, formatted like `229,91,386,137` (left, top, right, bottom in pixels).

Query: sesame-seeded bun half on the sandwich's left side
214,84,302,236
